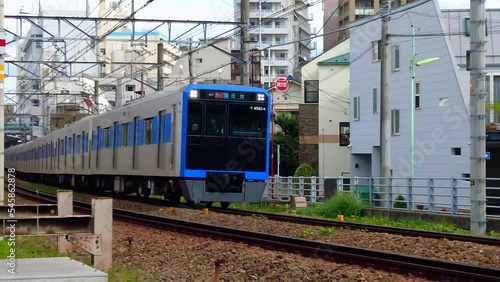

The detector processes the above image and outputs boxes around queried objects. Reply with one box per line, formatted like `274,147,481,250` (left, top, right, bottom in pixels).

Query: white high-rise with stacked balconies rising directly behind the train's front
234,0,316,88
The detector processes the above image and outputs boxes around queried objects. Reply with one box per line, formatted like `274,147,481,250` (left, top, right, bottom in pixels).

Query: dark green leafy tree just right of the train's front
274,113,299,176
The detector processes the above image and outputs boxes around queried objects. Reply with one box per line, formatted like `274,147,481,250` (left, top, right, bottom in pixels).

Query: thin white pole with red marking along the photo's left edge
0,0,6,205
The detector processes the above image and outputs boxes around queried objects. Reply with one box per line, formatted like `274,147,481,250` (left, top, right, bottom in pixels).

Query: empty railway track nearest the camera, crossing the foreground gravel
9,187,500,281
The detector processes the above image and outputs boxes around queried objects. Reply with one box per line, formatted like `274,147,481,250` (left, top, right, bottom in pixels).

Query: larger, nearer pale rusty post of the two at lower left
92,198,113,272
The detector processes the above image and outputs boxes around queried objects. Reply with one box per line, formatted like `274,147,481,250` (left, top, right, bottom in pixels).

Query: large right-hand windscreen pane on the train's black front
229,104,268,138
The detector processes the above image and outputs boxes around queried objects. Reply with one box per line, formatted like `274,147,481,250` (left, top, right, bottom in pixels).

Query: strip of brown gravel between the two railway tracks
110,200,500,268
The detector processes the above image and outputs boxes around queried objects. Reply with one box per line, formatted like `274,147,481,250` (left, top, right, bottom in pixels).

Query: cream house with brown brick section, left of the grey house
299,39,350,177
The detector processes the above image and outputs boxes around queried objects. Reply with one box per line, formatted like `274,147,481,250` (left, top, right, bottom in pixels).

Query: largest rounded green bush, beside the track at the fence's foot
316,192,368,218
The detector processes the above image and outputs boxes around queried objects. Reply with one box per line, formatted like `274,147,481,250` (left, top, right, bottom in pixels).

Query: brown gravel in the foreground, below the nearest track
67,221,434,282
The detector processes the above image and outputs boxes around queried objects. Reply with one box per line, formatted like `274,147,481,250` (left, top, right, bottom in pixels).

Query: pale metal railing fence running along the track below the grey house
263,176,500,217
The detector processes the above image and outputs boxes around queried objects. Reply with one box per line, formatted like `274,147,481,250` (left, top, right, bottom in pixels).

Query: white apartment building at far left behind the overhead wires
16,6,97,137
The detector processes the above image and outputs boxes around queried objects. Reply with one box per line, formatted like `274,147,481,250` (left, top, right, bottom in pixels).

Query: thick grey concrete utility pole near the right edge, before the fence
470,0,486,235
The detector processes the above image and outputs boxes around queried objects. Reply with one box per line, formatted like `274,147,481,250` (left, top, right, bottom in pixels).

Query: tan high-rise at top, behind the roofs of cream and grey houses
323,0,415,50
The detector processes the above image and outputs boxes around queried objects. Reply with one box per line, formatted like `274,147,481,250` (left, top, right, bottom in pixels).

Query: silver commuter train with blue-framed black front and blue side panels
6,84,271,207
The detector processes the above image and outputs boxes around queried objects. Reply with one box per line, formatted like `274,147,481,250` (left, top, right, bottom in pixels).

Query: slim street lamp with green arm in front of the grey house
410,25,439,178
